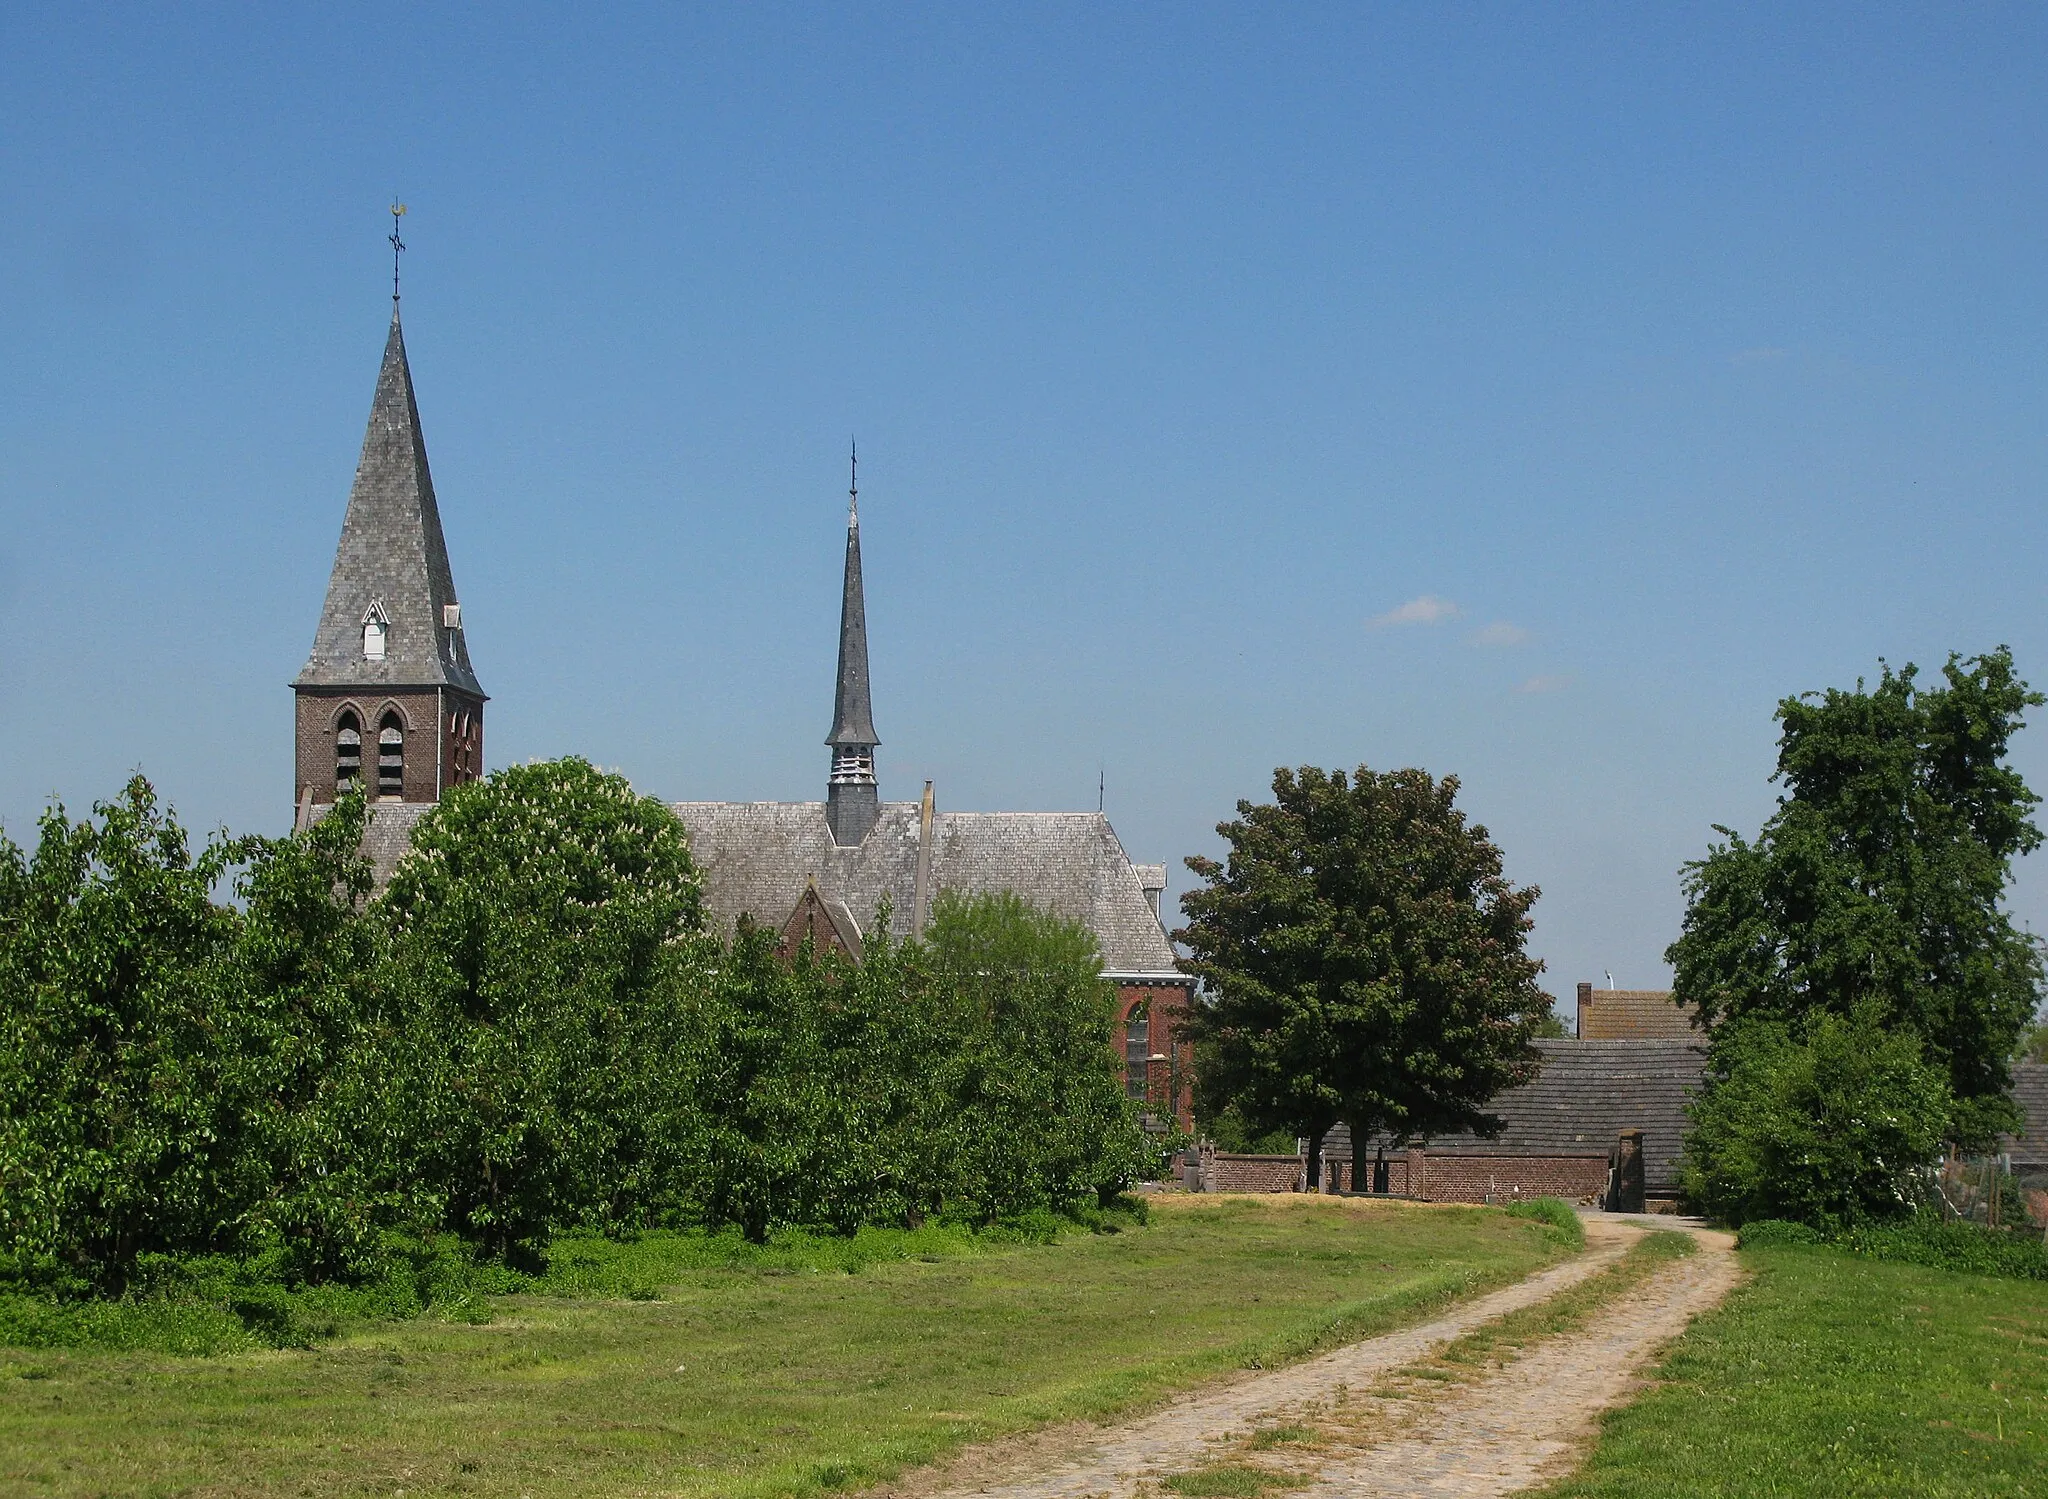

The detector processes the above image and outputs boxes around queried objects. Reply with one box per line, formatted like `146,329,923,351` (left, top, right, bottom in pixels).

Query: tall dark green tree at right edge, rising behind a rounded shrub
1665,647,2042,1145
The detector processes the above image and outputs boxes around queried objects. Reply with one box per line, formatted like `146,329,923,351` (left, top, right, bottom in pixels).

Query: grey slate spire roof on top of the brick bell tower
293,309,483,698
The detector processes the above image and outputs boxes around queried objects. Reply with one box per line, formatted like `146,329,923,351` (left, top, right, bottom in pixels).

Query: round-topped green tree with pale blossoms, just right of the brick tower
379,758,702,1251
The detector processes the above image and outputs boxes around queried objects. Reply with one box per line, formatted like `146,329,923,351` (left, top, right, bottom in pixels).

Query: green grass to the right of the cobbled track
1550,1249,2048,1499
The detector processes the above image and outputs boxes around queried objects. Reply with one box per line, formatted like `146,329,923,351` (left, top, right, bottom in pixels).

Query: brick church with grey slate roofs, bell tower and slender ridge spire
291,295,1194,1128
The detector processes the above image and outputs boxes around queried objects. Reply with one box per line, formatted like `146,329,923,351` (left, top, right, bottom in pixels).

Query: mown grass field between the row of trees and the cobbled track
0,1198,1563,1499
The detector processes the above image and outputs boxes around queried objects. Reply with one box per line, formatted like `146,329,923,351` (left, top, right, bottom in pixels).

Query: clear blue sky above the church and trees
0,4,2048,1019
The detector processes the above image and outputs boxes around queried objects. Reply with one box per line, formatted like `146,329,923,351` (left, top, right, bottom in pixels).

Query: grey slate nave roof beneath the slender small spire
676,801,1176,975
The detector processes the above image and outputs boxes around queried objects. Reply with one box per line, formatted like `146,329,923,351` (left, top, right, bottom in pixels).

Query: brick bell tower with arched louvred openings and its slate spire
291,297,485,823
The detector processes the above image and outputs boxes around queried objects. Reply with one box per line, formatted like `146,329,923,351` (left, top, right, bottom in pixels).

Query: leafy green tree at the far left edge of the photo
0,776,243,1288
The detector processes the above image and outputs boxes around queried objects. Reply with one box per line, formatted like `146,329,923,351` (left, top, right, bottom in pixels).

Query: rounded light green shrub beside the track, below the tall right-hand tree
1681,1012,1950,1233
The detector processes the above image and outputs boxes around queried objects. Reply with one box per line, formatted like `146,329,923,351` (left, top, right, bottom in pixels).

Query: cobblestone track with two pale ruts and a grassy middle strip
879,1218,1737,1499
